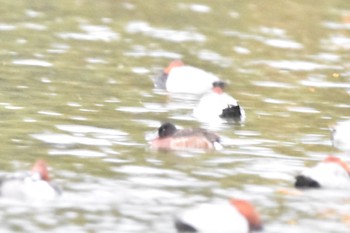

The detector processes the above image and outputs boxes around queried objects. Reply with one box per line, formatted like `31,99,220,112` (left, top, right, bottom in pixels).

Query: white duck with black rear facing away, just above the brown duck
193,81,245,121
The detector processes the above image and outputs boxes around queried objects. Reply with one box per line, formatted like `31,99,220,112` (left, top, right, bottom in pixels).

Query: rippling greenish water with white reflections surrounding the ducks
0,0,350,233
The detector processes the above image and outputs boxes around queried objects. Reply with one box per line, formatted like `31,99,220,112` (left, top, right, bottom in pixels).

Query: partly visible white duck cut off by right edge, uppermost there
331,120,350,151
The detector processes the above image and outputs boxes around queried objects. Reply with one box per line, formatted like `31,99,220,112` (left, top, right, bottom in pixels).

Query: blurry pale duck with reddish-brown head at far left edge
0,159,61,200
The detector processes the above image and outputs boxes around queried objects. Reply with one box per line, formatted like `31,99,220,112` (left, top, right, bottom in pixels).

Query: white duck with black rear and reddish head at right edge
294,156,350,189
